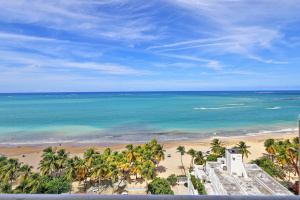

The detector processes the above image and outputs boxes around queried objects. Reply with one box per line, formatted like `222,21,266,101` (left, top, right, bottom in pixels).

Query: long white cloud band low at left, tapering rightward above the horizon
0,51,158,77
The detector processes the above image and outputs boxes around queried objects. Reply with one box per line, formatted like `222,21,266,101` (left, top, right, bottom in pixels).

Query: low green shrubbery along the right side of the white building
252,157,286,179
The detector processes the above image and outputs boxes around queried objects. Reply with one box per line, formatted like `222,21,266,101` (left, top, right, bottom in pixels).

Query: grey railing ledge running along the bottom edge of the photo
0,194,299,200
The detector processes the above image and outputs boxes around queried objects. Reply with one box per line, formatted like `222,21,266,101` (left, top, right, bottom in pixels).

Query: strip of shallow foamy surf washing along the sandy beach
0,127,298,148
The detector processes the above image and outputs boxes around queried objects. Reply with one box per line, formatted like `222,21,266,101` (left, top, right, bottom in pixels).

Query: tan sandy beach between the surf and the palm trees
0,132,298,177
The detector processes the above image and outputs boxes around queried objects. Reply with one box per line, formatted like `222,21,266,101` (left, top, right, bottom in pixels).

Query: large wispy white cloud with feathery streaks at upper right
156,0,300,64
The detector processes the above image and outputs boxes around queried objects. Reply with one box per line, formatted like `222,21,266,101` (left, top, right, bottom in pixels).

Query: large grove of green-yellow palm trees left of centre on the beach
0,139,164,194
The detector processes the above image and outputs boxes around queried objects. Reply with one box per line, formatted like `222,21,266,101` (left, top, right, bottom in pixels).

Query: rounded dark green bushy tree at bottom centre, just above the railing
148,178,174,195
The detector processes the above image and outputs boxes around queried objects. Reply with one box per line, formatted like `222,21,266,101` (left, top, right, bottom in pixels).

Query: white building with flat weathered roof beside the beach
188,149,293,195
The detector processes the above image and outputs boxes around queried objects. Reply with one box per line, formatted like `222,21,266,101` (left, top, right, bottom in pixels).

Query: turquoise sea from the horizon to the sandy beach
0,91,300,146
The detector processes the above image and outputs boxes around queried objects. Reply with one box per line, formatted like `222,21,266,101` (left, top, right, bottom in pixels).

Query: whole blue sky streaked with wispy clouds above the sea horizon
0,0,300,92
